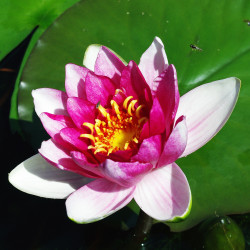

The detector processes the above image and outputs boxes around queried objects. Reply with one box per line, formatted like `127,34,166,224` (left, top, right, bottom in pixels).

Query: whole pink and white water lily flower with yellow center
9,37,240,223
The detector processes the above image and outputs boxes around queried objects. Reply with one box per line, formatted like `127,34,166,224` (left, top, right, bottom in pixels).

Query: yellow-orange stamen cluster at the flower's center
80,90,147,156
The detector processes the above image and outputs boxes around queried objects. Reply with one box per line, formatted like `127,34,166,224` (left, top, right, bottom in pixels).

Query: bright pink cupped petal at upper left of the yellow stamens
86,71,115,106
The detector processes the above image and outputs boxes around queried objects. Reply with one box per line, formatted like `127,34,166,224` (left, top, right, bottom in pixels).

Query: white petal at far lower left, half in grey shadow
9,154,92,199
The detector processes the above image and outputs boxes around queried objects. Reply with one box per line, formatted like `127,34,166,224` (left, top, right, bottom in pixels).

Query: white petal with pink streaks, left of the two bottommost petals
66,179,135,223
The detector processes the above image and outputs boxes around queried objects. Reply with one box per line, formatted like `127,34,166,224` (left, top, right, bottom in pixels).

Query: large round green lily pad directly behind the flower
12,0,250,231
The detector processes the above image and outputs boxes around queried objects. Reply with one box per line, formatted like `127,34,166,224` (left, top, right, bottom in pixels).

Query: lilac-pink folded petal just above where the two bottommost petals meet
101,159,153,187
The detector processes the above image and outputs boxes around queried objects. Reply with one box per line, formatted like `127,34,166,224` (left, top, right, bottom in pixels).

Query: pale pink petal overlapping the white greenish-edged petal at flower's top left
95,46,125,87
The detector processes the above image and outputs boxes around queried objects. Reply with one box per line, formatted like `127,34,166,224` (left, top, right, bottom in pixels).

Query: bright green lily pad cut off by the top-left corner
0,0,79,61
